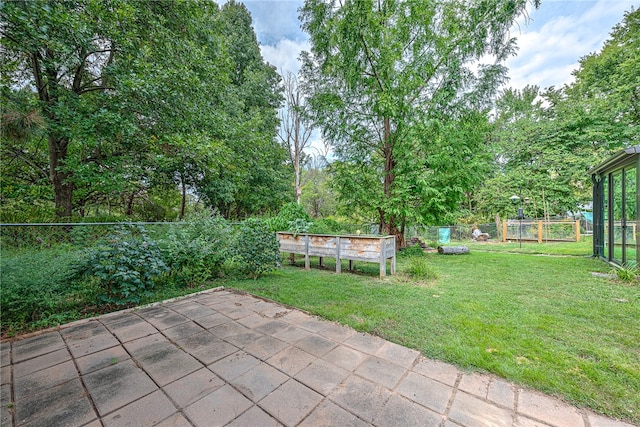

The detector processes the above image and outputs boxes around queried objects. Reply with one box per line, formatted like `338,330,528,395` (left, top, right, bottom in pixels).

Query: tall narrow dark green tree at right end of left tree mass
199,1,291,218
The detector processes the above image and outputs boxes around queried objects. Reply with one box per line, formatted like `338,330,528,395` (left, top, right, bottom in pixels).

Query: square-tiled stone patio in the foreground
0,290,629,427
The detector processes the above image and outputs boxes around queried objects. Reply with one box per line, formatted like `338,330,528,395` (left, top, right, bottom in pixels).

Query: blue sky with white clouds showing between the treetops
236,0,640,89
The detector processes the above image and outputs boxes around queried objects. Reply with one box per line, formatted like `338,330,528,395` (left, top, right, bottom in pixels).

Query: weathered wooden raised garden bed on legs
276,232,396,277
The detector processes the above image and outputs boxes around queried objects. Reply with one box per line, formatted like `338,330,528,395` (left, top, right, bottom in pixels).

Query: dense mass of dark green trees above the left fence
0,0,289,221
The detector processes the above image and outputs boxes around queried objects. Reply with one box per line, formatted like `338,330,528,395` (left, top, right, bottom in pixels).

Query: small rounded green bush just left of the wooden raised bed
232,218,281,279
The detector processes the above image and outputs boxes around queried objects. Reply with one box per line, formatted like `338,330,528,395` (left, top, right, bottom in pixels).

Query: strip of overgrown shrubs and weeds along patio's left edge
0,216,280,335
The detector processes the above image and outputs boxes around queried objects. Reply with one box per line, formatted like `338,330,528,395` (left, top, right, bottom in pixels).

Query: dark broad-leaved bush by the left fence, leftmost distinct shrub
75,226,168,306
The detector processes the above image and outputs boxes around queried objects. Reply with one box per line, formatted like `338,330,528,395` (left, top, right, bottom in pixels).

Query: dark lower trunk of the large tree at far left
48,135,73,217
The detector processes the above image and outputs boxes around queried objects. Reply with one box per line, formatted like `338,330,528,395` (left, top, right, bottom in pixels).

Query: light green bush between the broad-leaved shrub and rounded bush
164,211,231,286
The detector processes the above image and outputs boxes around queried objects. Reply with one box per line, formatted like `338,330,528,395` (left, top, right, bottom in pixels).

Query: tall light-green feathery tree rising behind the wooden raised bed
301,0,538,246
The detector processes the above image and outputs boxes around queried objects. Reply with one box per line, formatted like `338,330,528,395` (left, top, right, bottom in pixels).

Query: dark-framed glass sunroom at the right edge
589,145,640,266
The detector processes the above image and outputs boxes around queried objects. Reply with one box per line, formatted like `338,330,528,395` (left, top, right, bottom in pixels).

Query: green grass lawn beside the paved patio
225,250,640,423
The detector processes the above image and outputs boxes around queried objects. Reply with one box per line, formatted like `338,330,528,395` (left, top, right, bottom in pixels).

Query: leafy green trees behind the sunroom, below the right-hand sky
473,10,640,222
